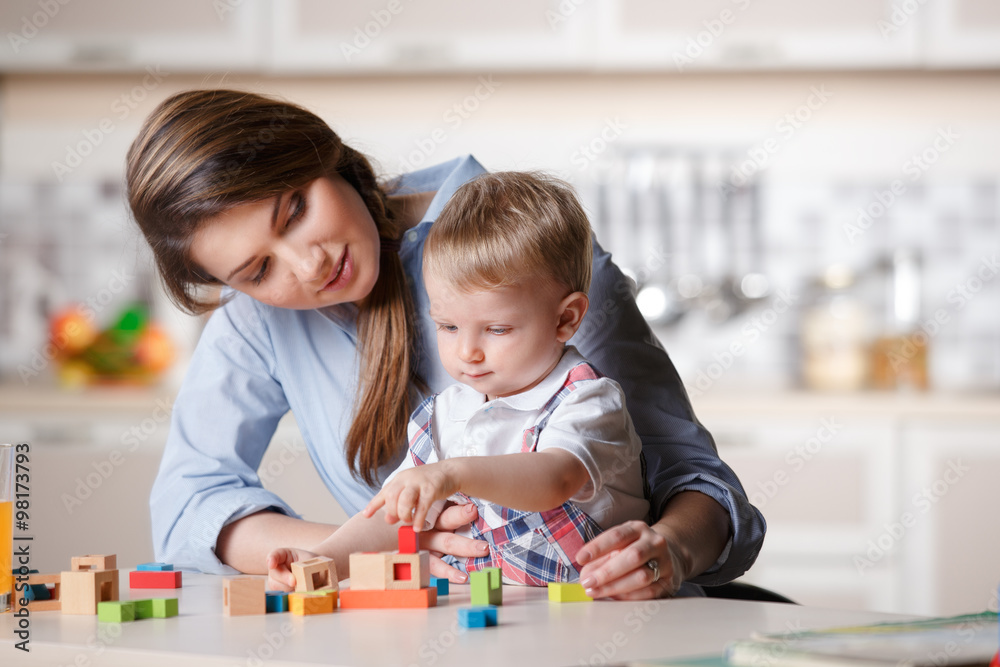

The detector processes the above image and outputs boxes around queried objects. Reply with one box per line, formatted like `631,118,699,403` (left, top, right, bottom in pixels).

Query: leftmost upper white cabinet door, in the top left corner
0,0,266,72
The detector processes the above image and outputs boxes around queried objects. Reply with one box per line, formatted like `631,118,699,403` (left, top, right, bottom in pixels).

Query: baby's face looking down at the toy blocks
425,272,565,400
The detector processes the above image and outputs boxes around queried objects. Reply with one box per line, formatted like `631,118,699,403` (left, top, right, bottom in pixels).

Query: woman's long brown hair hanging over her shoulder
126,90,420,485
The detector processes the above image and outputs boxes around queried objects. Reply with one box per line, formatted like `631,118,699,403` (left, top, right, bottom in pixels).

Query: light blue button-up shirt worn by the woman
150,156,765,584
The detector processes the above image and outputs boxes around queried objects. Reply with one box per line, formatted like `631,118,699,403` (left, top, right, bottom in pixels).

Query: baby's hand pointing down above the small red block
361,462,459,532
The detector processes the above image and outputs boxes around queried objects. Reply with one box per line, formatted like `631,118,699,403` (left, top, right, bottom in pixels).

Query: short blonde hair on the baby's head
424,171,593,294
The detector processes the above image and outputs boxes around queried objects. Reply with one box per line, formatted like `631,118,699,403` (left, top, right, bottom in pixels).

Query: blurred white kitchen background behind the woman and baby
0,0,1000,613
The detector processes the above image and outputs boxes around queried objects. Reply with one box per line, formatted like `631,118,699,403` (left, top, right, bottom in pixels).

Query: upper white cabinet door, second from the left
269,0,594,73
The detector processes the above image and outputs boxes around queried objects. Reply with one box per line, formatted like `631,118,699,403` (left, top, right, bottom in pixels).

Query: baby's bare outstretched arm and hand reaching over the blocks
362,448,590,532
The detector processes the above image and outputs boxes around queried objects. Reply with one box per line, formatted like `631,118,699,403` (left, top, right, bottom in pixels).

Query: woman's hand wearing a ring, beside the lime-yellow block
577,521,688,600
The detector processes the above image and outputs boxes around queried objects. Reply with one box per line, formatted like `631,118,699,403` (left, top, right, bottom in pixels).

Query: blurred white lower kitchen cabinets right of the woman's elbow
695,392,1000,615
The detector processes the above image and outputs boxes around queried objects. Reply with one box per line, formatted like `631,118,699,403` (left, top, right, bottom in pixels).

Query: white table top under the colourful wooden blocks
0,570,916,667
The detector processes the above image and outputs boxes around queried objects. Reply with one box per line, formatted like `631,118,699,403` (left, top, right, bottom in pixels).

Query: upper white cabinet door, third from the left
598,0,920,72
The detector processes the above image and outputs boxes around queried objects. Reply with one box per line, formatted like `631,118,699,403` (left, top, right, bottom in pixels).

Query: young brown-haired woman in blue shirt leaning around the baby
127,90,765,599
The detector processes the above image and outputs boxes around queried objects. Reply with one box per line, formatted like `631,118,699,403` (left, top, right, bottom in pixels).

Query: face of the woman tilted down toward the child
191,176,379,310
